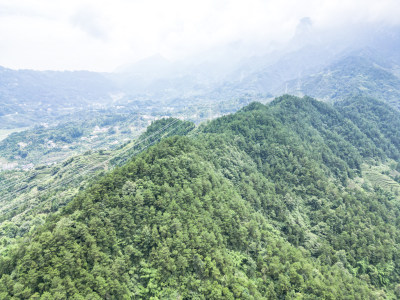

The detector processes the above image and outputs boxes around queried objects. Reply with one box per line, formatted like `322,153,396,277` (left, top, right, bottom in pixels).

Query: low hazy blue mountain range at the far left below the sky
0,67,118,128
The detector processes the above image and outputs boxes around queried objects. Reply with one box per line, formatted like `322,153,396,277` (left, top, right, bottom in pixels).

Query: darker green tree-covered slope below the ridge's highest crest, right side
205,96,400,288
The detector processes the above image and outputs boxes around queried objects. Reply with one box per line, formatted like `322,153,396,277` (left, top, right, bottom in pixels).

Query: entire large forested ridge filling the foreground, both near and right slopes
0,96,400,299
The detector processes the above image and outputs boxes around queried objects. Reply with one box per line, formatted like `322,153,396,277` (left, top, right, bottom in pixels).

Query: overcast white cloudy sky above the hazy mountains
0,0,400,72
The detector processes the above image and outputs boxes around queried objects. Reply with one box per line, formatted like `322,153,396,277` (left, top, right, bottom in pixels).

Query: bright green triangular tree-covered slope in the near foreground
1,138,376,299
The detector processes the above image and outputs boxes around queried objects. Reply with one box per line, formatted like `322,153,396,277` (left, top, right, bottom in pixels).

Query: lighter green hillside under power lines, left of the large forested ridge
0,118,194,256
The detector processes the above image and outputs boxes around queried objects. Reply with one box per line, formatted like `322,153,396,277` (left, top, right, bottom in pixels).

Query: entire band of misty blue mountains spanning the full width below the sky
0,18,400,128
